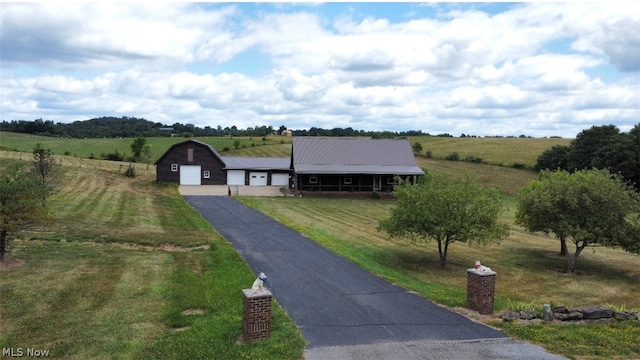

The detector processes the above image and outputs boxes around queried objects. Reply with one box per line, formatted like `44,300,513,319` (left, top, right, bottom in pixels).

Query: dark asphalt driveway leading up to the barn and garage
185,196,556,359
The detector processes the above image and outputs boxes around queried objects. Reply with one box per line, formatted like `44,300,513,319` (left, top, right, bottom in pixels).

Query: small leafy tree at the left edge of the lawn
0,171,45,261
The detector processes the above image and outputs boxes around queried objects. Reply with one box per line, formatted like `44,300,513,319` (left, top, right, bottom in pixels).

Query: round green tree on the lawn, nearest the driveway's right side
378,174,509,267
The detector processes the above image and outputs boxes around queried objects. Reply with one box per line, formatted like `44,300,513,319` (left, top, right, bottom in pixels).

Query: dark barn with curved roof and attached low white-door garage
155,139,290,186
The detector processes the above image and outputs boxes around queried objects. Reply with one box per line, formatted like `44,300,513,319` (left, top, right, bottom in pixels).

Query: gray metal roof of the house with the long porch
293,137,424,175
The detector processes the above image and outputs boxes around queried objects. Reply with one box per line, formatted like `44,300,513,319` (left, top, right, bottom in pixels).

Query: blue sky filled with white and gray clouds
0,1,640,137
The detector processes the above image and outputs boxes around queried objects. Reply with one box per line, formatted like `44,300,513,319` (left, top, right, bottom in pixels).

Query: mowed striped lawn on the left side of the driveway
0,152,305,359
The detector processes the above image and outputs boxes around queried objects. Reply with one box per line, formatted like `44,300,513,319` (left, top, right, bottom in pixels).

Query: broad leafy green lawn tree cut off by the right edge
516,169,640,272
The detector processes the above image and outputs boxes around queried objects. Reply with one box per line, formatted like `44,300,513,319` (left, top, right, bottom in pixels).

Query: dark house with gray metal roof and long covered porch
290,137,424,193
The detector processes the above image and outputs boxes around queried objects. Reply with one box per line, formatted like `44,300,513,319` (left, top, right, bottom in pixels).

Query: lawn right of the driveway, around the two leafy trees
240,190,640,359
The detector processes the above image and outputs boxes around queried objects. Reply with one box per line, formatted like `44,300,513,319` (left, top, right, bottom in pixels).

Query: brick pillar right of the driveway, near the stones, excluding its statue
467,269,497,315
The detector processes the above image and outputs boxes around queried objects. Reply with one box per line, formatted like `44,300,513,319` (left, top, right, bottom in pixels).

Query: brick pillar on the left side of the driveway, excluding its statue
242,289,272,342
